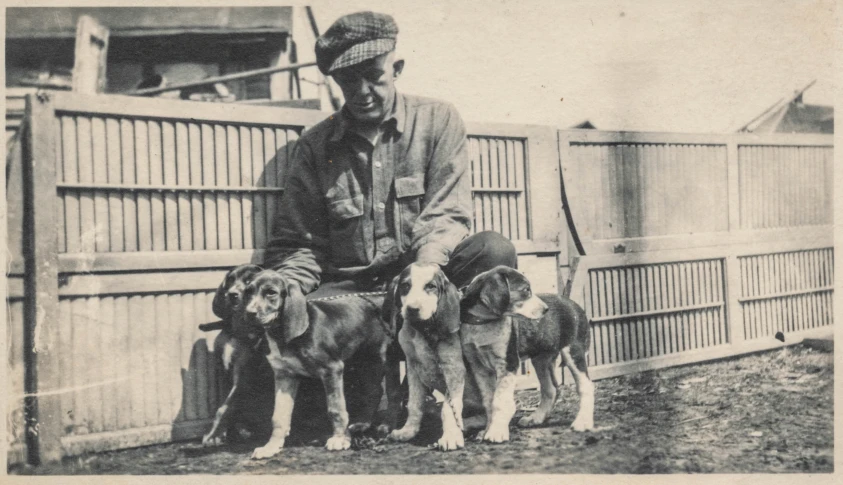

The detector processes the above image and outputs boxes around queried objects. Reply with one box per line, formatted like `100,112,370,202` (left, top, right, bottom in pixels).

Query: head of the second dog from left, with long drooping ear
245,270,308,343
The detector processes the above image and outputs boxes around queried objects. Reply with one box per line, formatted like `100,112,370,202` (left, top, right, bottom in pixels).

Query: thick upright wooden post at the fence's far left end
23,93,62,465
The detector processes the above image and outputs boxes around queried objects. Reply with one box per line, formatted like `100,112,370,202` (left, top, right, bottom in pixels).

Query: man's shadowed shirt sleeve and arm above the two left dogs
265,140,329,294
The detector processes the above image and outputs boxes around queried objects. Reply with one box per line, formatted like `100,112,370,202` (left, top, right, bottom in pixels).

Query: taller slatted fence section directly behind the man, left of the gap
7,93,567,462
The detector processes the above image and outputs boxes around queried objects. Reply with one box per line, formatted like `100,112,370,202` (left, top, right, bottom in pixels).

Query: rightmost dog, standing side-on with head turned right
460,266,594,442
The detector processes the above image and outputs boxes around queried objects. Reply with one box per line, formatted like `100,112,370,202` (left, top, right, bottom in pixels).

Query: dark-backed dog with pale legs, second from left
245,270,395,459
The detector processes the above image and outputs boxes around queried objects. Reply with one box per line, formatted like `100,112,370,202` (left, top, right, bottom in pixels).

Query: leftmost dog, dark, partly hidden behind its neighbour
199,264,273,446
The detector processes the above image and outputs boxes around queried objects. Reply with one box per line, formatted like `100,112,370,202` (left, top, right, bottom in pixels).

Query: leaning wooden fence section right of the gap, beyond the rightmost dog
559,131,834,378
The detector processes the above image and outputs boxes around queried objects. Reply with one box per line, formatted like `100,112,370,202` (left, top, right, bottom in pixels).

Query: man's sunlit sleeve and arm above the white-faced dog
412,105,471,265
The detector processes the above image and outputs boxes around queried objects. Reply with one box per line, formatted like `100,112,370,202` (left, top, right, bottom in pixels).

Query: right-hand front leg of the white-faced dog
437,335,465,451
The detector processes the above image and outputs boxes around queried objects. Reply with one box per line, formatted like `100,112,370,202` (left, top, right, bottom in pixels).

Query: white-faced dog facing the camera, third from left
383,263,465,451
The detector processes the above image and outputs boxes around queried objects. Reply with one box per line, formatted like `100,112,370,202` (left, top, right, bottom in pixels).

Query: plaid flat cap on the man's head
316,12,398,75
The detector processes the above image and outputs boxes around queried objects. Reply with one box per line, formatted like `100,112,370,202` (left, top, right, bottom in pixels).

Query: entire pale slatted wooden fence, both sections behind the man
7,93,833,462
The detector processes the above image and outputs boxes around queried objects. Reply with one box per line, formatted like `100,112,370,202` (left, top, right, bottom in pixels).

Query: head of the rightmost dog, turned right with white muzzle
461,266,547,319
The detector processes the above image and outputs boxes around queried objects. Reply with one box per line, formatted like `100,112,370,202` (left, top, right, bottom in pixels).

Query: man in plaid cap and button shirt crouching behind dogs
265,12,517,438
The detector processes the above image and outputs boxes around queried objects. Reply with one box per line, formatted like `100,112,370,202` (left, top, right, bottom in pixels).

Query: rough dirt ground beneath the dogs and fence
9,346,834,475
